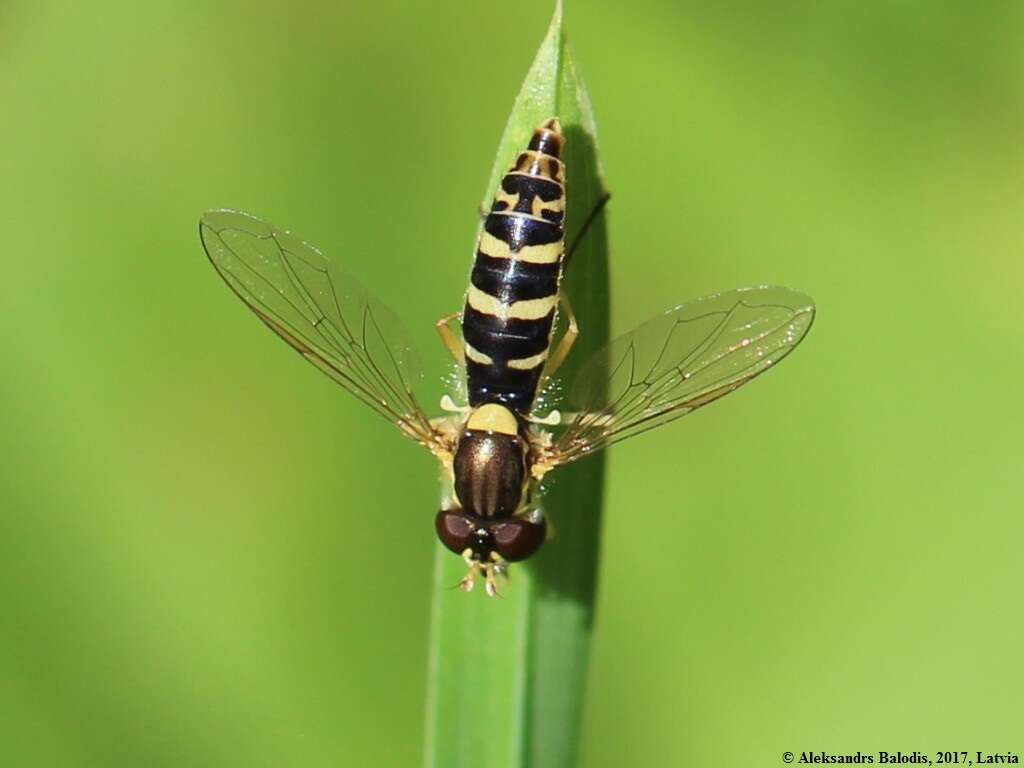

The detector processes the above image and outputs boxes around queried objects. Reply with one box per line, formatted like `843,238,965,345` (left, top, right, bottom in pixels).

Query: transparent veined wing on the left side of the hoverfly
200,211,440,446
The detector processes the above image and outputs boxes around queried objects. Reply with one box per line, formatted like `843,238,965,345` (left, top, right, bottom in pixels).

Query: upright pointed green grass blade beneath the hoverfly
425,2,609,768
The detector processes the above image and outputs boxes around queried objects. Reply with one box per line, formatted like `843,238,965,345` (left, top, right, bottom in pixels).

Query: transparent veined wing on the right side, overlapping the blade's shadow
541,287,814,469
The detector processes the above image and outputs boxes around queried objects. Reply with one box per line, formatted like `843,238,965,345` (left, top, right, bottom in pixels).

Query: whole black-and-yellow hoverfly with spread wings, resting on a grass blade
200,118,814,595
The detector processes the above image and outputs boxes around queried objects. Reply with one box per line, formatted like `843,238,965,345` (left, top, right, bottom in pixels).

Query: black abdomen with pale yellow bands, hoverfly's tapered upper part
462,118,565,415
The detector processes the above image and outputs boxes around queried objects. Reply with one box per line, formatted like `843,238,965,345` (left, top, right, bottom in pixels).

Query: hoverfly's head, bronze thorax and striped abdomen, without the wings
436,118,565,592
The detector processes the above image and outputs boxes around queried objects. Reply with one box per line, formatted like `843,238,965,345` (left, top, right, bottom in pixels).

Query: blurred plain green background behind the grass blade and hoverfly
0,0,1024,768
